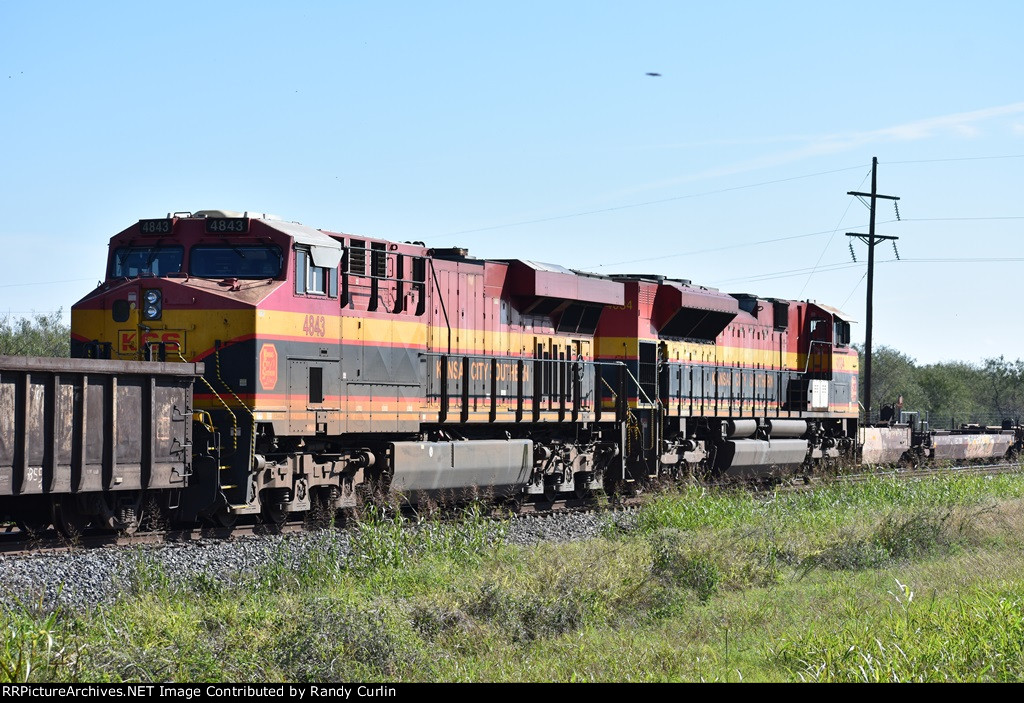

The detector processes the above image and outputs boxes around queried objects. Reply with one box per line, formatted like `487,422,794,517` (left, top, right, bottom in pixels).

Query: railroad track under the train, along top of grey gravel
0,463,1024,558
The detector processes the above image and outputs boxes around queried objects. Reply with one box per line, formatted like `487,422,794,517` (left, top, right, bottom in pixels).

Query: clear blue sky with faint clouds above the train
0,5,1024,362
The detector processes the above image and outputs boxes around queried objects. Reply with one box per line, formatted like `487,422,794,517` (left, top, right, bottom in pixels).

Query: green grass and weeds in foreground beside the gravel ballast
6,475,1024,682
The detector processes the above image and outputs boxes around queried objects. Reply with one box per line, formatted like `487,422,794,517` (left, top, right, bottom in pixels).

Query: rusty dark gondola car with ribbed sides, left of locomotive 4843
0,356,203,533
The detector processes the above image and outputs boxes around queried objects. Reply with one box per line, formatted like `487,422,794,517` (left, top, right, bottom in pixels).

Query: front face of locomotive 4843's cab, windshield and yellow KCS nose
72,211,296,362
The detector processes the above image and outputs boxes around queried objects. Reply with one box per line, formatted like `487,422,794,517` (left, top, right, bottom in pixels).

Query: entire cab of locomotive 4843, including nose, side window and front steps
72,211,358,517
